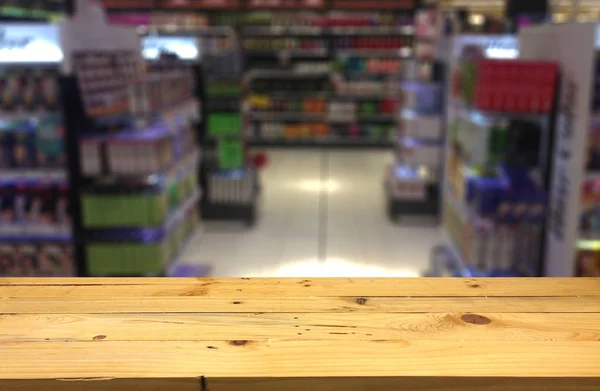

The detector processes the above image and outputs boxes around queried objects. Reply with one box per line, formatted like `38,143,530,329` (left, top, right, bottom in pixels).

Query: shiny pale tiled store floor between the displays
183,150,441,277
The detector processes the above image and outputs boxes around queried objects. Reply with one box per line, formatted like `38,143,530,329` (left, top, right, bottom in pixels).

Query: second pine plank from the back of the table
0,296,600,314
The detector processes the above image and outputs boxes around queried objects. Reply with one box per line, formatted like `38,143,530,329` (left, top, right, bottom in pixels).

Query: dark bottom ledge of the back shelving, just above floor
247,137,393,149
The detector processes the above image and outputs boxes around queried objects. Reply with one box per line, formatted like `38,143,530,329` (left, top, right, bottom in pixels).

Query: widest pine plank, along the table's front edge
0,340,600,379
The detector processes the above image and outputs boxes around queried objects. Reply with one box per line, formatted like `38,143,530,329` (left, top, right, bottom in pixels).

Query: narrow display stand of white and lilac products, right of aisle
385,10,446,221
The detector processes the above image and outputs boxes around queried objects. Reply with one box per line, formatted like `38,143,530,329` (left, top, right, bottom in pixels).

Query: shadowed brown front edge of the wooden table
0,377,600,391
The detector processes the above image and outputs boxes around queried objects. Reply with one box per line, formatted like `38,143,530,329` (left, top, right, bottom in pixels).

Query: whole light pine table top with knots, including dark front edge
0,278,600,391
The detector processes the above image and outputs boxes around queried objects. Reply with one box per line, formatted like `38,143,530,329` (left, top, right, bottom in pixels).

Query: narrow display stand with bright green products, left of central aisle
201,29,258,226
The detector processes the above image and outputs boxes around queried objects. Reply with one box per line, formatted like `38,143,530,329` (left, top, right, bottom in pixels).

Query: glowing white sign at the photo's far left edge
0,24,63,64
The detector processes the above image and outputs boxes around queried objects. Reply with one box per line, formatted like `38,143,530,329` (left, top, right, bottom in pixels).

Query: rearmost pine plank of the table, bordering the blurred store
0,278,600,298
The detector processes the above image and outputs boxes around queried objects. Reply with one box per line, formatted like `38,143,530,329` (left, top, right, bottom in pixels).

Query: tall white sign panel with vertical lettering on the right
520,24,596,277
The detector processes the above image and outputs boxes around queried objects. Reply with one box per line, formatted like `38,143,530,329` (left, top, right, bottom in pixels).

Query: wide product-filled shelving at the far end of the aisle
232,2,414,148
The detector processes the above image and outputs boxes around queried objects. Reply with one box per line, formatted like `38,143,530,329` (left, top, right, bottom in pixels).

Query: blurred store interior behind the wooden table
0,0,600,277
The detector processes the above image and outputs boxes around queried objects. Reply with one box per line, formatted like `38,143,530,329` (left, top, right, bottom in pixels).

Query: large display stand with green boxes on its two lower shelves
61,1,200,276
